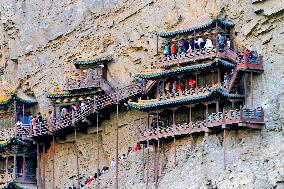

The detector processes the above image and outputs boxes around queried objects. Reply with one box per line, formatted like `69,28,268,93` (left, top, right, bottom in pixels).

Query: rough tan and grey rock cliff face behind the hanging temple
0,0,284,188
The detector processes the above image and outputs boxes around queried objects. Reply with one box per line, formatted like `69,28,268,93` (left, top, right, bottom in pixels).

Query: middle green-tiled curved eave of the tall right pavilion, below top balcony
135,58,235,80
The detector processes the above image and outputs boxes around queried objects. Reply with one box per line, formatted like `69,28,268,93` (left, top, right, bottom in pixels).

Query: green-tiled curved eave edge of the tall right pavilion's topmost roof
154,18,235,38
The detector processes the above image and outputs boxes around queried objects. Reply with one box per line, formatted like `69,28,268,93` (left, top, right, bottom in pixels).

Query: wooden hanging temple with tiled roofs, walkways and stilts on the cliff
0,17,265,188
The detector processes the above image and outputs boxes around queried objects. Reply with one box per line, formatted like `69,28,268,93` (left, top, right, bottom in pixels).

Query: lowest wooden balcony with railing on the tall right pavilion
138,108,264,142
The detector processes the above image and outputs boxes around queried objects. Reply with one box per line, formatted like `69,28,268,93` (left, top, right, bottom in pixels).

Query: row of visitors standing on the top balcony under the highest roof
164,34,231,57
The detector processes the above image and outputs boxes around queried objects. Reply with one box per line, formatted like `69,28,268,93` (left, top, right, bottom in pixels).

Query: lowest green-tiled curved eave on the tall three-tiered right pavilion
128,88,244,110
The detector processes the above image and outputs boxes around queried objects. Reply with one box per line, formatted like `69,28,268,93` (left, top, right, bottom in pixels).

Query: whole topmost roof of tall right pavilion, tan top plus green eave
154,16,235,38
